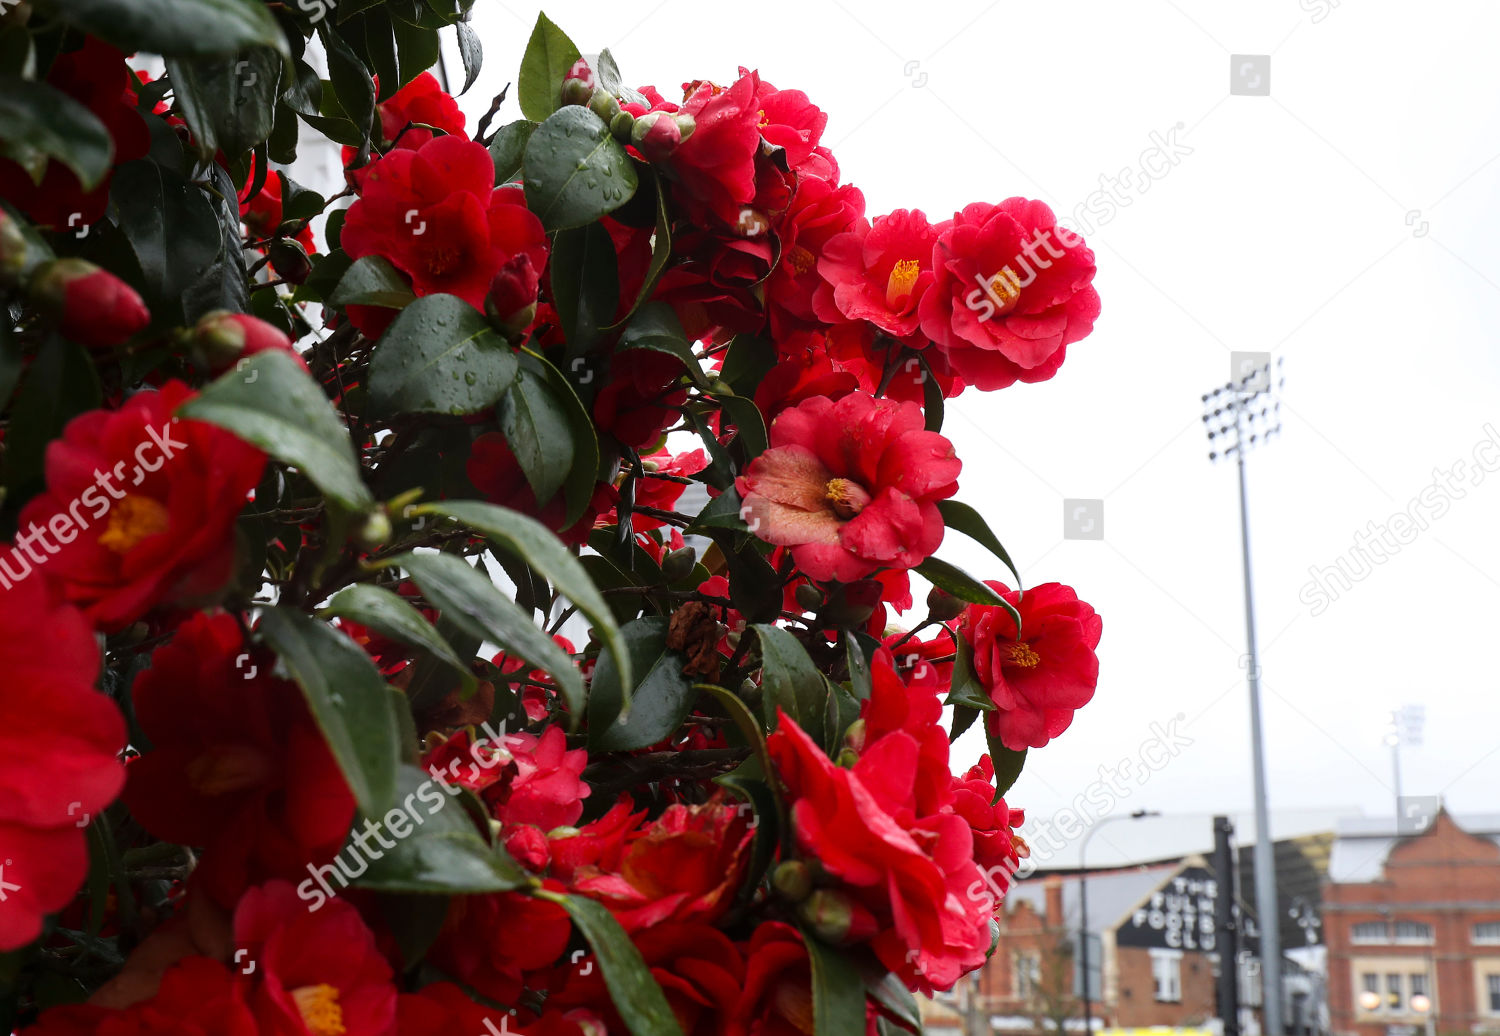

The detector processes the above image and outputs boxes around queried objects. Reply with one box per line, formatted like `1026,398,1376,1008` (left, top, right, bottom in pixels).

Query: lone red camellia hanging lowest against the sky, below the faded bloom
959,580,1104,751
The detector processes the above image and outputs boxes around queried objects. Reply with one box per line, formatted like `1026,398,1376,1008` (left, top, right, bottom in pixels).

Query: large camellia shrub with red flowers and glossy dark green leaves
0,0,1101,1036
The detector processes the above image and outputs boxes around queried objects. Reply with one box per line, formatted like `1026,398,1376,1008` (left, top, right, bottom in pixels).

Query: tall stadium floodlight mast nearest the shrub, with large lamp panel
1203,354,1284,1036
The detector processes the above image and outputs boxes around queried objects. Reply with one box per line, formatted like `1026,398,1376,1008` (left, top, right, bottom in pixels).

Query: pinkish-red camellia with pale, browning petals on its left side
735,391,962,582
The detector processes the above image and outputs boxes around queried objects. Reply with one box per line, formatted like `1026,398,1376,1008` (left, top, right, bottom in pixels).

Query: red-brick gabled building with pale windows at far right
1323,811,1500,1036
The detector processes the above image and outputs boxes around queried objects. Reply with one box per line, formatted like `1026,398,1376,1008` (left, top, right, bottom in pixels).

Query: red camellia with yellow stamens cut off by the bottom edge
234,882,396,1036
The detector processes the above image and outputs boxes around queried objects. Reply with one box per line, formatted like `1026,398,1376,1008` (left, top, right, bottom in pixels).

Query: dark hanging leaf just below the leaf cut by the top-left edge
167,46,282,156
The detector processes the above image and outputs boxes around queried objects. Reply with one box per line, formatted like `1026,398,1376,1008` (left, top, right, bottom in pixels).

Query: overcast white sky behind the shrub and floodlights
450,0,1500,862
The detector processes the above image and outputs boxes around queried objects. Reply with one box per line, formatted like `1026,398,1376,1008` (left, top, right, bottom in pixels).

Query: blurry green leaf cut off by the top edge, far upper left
53,0,290,57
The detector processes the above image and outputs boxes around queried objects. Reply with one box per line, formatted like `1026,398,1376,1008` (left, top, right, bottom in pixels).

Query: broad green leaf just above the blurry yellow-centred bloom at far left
179,349,375,511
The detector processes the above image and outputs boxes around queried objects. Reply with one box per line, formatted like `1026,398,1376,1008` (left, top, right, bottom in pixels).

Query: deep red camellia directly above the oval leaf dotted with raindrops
339,136,548,317
